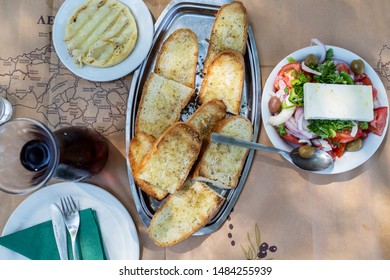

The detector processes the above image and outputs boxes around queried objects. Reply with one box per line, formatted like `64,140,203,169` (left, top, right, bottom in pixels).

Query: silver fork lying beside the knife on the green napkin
61,196,80,260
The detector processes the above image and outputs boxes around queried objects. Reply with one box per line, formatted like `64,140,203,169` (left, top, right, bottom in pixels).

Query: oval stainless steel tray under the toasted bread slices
126,0,261,235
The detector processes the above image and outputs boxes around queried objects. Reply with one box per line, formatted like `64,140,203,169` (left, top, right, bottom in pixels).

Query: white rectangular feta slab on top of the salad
303,83,374,121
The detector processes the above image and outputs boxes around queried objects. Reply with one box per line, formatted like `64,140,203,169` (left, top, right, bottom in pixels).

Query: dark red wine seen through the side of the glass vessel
54,126,108,181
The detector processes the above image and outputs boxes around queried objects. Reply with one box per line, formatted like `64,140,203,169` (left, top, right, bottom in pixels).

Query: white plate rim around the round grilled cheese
53,0,154,82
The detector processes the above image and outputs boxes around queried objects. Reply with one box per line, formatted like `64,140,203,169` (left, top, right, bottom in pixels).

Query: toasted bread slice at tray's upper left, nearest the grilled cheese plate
154,28,199,88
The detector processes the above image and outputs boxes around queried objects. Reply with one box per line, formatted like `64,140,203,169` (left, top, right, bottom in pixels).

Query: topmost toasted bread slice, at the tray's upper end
203,1,248,73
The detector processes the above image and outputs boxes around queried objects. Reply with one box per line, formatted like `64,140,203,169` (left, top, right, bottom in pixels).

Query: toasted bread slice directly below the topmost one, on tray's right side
198,51,244,115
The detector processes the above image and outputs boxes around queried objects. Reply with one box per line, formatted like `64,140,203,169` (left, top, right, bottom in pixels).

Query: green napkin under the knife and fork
0,208,106,260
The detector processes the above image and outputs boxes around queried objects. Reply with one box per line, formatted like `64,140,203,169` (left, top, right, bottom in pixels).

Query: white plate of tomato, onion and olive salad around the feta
261,39,389,174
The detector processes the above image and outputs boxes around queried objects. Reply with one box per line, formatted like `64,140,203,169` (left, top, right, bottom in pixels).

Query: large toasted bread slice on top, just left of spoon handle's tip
134,123,202,200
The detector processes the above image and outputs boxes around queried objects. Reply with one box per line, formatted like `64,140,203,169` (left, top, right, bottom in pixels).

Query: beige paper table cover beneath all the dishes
0,0,390,259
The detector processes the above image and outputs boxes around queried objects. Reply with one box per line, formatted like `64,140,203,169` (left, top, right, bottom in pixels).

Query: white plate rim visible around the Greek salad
261,45,389,174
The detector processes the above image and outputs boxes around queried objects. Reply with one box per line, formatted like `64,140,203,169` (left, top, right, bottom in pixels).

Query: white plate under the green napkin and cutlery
0,182,140,260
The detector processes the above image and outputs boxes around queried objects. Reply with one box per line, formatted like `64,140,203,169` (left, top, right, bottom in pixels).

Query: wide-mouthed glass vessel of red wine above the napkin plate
0,118,108,194
